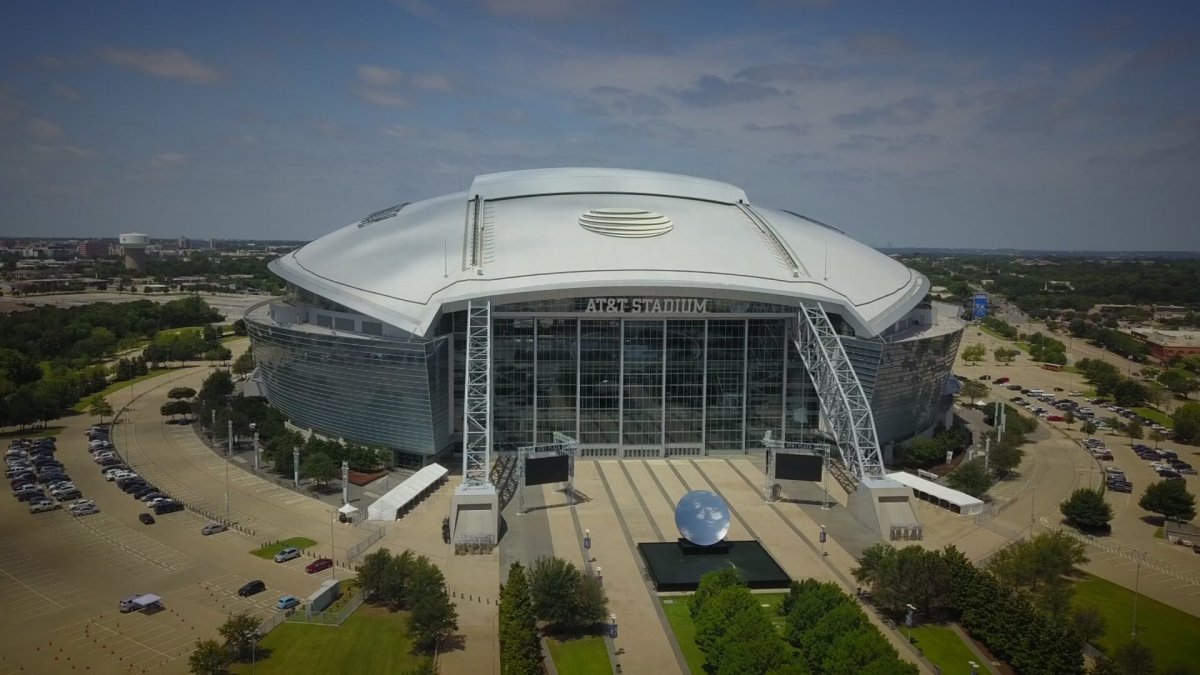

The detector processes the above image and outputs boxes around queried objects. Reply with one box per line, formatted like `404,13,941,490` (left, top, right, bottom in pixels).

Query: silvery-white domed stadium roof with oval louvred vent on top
271,168,929,335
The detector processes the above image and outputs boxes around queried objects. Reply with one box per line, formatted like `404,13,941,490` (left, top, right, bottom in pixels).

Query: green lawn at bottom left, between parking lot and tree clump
233,605,425,675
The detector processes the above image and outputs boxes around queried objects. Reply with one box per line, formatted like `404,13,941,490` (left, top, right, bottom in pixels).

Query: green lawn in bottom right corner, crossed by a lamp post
1074,569,1200,671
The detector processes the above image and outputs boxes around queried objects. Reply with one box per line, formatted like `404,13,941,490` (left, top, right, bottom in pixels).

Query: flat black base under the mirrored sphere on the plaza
637,539,792,592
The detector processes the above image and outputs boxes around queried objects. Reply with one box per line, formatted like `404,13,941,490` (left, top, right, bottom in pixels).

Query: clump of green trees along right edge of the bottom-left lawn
356,548,458,652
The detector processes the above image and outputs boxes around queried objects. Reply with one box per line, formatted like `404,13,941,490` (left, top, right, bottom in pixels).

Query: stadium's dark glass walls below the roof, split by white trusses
247,291,961,461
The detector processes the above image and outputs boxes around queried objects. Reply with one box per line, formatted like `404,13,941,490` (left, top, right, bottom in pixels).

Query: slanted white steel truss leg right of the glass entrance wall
796,304,884,482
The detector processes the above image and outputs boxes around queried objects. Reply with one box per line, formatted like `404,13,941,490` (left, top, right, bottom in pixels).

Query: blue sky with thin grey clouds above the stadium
0,0,1200,250
